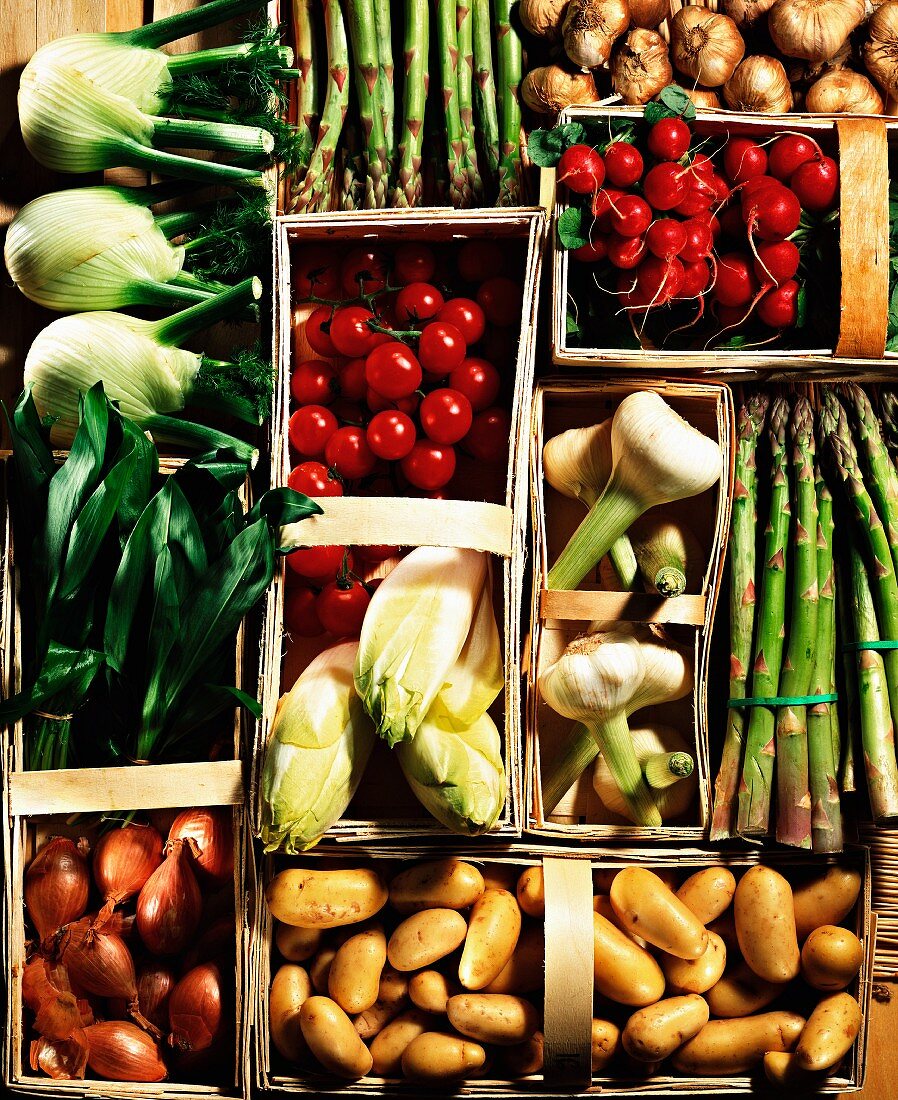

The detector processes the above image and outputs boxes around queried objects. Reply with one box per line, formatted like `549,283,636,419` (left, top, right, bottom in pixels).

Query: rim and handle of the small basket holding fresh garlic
524,377,735,843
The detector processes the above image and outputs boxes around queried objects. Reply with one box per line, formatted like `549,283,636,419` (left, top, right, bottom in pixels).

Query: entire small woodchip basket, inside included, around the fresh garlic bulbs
525,376,735,844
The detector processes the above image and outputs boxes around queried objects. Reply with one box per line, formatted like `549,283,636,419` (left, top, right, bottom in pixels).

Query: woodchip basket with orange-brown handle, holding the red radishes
551,107,898,380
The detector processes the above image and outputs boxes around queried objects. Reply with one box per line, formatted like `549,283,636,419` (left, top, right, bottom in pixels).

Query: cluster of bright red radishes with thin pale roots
558,118,839,329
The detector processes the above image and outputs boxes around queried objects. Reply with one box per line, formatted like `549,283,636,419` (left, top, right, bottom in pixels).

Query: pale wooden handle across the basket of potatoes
543,856,593,1091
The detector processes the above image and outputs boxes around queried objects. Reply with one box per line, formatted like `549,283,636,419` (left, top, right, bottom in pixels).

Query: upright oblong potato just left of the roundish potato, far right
733,865,801,982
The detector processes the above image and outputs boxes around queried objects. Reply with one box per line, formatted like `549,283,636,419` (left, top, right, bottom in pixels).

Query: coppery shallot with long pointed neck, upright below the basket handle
138,840,202,955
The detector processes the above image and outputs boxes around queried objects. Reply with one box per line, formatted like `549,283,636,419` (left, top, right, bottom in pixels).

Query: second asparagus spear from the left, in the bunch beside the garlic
736,397,790,836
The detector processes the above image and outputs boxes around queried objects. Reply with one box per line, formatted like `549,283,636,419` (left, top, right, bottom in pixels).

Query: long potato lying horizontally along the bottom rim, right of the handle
674,1010,804,1077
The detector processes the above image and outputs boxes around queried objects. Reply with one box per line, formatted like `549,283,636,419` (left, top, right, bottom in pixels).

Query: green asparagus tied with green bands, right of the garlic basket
711,384,898,851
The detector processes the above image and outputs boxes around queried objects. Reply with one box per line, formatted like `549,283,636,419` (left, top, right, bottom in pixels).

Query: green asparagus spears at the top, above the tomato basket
287,0,523,212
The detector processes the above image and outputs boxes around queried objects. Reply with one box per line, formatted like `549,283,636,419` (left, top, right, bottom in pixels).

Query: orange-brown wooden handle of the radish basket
835,119,889,359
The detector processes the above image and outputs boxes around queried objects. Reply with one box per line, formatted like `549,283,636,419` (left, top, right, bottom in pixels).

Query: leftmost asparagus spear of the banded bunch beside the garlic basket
711,394,769,840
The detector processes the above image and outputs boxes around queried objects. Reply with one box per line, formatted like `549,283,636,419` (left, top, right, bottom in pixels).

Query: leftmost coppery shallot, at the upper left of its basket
25,836,90,942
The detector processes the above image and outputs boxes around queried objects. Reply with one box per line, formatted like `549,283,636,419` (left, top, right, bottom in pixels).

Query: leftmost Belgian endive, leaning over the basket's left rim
262,641,374,853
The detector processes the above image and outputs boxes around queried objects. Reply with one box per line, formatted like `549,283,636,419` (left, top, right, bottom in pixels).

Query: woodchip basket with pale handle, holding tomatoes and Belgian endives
252,209,545,839
